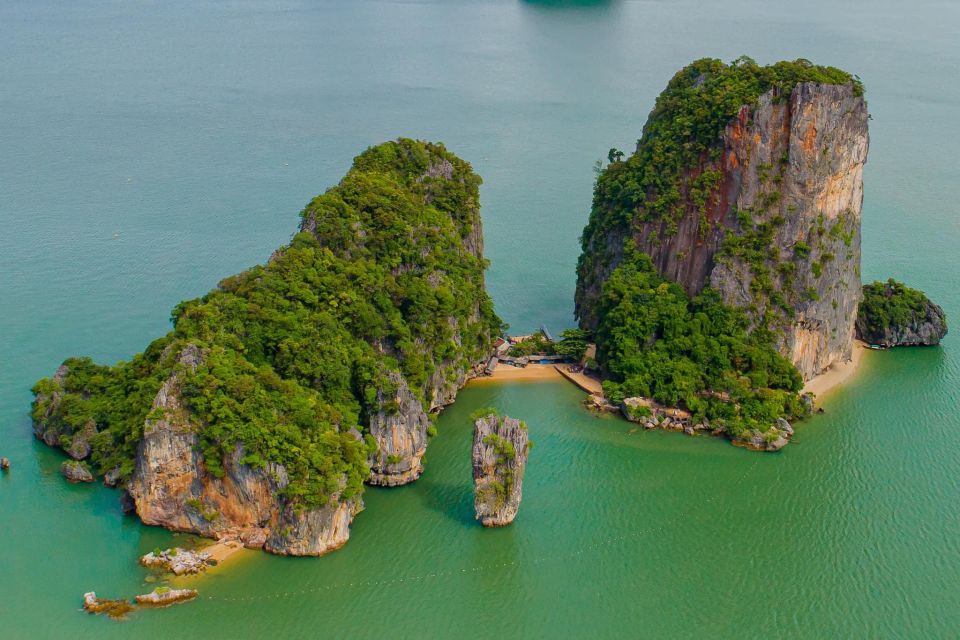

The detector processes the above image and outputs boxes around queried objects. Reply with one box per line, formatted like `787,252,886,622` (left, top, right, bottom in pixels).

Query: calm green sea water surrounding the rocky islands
0,0,960,639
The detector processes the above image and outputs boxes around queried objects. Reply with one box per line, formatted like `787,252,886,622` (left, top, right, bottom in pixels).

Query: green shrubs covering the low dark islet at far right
857,278,946,340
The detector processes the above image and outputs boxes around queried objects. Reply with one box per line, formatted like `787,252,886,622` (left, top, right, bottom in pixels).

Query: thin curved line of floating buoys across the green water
199,460,757,602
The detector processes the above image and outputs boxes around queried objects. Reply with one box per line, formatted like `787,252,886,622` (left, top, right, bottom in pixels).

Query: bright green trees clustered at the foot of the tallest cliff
596,248,804,436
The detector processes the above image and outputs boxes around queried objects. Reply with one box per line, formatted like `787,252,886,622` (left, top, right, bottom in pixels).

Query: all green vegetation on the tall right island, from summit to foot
577,57,863,436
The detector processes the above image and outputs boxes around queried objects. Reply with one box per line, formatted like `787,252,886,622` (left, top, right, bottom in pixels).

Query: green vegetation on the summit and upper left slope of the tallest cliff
577,57,863,328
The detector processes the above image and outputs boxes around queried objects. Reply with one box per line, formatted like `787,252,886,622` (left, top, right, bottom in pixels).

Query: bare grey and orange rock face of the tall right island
577,62,868,379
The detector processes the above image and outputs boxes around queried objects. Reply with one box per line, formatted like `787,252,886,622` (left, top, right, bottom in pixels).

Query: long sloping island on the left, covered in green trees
33,139,500,555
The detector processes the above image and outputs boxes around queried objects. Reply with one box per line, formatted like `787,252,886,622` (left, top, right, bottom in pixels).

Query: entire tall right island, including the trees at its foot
576,58,869,450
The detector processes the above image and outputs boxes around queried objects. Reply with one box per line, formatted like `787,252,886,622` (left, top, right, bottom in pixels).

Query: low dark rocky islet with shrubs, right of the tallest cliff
857,279,947,348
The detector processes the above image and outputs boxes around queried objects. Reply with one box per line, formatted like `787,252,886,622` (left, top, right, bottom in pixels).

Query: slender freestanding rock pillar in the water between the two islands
473,414,530,527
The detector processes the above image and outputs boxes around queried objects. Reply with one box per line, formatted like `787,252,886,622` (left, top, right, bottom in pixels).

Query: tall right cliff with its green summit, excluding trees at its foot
576,59,868,380
